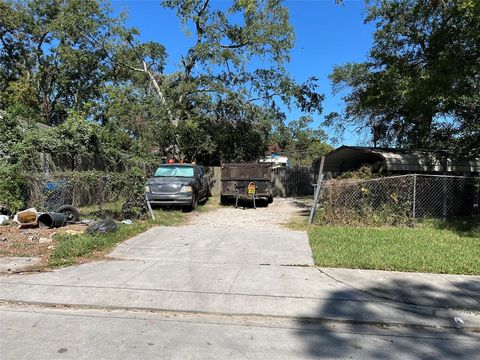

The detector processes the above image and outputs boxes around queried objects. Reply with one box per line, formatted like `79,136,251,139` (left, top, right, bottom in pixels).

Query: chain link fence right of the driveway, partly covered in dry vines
317,175,480,225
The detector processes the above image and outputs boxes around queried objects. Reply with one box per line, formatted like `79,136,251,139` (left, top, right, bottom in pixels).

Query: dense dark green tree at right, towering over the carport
326,0,480,155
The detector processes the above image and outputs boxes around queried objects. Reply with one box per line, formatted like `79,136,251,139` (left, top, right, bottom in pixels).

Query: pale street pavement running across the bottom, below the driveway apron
0,306,480,360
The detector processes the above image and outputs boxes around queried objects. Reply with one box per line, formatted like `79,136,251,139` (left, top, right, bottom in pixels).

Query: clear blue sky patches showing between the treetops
112,0,373,145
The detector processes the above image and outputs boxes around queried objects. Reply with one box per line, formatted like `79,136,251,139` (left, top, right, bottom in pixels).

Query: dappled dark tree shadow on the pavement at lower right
296,279,480,359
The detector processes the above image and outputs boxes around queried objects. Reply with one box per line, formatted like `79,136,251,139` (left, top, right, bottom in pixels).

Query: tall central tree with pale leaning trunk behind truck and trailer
112,0,323,160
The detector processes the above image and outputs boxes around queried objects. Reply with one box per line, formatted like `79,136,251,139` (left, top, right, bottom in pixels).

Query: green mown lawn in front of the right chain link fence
295,218,480,275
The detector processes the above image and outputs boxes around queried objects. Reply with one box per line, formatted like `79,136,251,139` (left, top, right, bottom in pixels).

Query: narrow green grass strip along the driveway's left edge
48,210,187,267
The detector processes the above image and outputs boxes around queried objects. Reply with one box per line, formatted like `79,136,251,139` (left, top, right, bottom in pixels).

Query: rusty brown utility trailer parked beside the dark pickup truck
220,163,273,206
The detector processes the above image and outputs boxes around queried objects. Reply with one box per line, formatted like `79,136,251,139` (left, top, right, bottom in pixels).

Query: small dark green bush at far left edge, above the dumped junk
0,164,26,213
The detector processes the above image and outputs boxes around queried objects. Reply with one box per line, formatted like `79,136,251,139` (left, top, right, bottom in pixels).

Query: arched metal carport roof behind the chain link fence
324,145,480,173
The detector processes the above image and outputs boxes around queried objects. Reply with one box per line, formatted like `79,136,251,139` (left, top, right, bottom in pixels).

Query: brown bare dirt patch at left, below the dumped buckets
0,224,87,267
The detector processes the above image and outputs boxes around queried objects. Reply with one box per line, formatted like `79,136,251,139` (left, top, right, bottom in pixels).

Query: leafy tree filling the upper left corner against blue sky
0,0,122,125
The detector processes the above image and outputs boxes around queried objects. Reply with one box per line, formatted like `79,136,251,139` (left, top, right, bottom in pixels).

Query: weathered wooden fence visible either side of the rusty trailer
205,166,318,197
